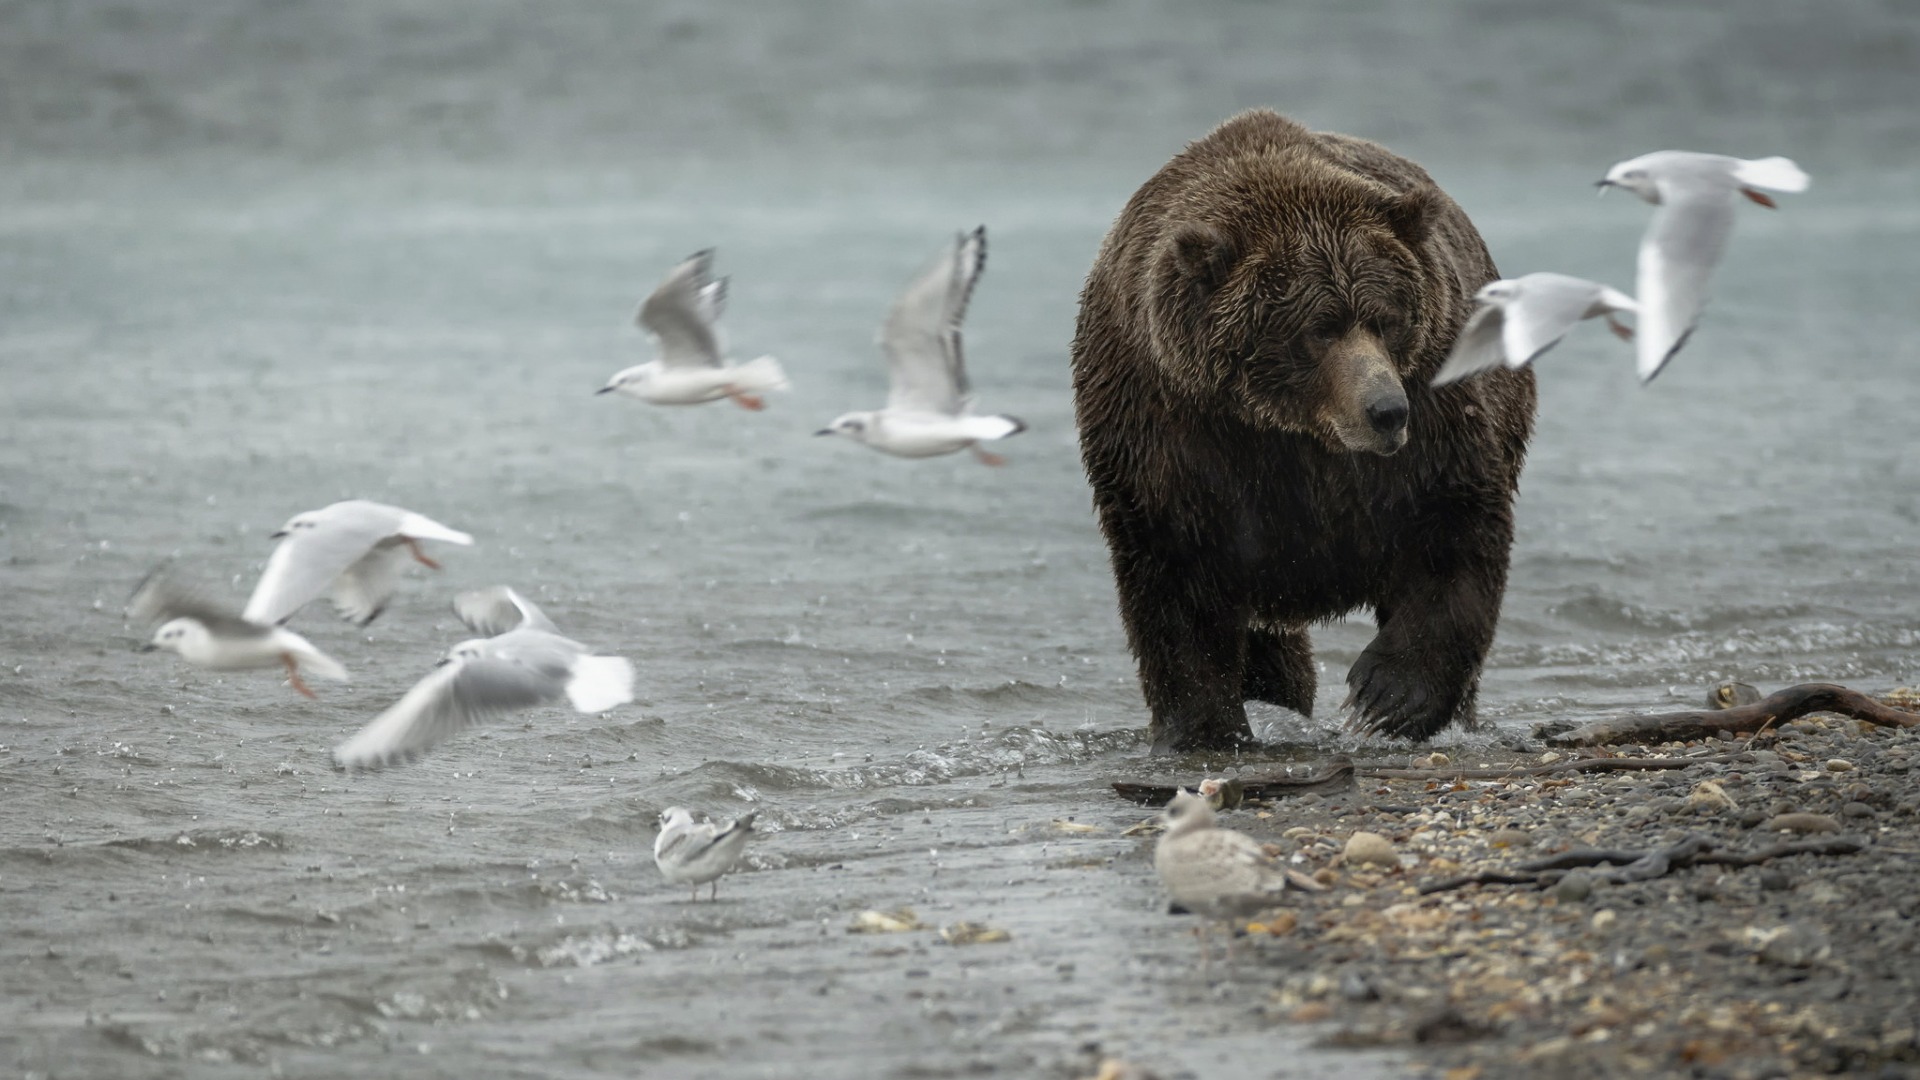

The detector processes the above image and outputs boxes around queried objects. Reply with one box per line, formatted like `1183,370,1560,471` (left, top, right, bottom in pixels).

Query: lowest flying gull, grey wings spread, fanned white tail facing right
334,584,634,769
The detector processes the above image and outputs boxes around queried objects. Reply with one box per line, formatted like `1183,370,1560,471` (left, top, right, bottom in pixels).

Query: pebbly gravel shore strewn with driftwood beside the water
1113,690,1920,1080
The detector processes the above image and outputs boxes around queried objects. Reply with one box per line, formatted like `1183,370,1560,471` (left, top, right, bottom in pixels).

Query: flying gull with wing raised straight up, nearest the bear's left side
814,225,1027,465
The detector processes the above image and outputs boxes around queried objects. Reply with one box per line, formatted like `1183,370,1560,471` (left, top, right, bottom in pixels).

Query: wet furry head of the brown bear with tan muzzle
1150,163,1448,454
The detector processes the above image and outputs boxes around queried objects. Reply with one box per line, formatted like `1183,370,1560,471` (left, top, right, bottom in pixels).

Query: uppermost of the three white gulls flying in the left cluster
242,500,474,626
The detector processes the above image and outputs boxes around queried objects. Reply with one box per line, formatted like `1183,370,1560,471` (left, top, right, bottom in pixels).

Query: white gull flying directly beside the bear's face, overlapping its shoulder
1434,273,1640,386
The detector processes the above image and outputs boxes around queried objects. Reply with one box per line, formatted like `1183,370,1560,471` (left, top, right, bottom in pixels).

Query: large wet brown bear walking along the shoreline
1073,110,1534,751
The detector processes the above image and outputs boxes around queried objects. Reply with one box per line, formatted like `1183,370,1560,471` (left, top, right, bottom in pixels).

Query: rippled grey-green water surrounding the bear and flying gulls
0,0,1920,1076
